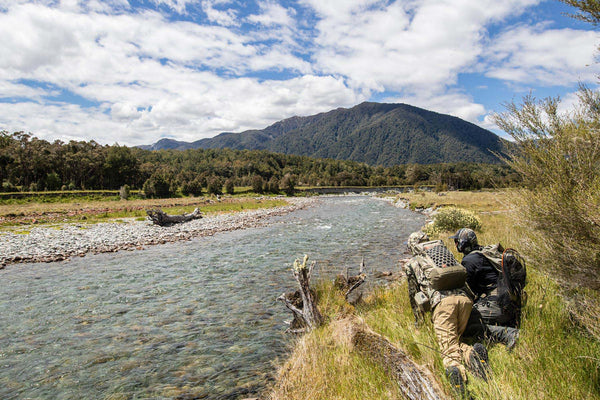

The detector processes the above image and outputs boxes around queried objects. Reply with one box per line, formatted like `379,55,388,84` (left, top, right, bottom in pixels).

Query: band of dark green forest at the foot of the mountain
0,131,519,197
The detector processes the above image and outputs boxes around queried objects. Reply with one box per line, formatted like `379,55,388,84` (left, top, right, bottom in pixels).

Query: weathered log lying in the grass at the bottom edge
333,319,447,400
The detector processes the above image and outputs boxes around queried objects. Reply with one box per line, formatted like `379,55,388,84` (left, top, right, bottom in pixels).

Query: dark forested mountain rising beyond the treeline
139,102,506,166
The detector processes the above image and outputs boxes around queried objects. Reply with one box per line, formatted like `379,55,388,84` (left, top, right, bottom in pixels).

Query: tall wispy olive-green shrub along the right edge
496,87,600,324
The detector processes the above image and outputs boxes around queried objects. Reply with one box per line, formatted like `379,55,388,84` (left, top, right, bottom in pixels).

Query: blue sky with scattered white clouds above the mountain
0,0,600,146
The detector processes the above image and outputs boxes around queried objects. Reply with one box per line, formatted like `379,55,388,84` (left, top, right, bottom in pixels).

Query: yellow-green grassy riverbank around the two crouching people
268,192,600,400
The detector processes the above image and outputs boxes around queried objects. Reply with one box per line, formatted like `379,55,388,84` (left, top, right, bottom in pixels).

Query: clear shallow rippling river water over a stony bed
0,196,424,400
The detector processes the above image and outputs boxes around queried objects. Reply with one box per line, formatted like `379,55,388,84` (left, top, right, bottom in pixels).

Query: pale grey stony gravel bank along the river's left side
0,197,317,268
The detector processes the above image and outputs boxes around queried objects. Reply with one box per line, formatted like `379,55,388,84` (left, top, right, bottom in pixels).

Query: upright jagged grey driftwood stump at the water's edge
277,256,323,333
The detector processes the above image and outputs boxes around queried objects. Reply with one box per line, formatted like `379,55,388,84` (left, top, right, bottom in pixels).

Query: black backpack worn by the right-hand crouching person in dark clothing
476,244,527,326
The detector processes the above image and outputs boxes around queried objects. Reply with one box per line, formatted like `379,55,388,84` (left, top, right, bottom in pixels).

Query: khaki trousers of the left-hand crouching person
431,295,473,379
